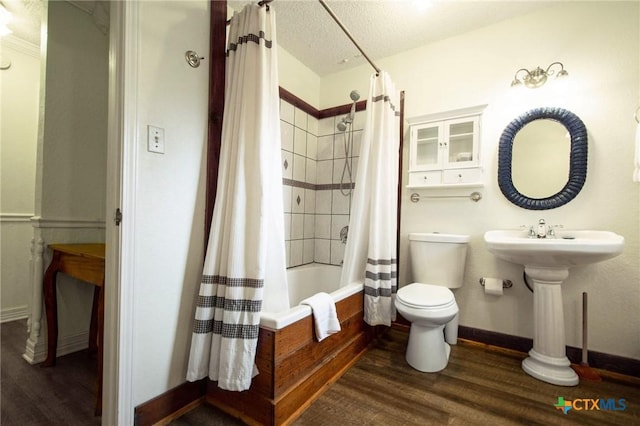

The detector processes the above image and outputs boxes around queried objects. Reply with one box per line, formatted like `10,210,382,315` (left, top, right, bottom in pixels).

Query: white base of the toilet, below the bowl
405,323,451,373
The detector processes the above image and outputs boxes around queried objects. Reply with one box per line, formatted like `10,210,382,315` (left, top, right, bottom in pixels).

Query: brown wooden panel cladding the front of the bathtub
206,292,374,425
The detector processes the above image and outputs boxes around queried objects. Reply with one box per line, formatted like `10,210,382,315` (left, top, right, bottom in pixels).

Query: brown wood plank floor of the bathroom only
171,329,640,426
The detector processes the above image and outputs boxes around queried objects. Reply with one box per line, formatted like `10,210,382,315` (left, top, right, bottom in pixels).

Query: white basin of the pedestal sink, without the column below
484,230,624,268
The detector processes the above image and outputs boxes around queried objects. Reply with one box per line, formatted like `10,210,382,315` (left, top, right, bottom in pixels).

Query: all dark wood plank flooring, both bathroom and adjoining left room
0,321,640,426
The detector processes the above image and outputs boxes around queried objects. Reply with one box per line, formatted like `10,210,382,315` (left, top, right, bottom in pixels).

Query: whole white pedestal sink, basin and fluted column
484,230,624,386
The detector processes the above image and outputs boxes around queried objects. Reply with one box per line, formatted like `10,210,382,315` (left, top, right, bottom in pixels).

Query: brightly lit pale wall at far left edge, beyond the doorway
0,36,40,321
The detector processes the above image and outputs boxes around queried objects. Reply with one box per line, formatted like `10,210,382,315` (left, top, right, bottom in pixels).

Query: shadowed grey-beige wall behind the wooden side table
27,2,109,352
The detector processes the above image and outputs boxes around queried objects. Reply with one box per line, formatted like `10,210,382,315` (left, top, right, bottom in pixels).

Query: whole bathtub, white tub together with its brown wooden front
206,264,375,425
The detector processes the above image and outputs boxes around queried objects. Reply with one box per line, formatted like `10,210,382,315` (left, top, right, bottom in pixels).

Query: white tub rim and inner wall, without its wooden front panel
260,263,363,330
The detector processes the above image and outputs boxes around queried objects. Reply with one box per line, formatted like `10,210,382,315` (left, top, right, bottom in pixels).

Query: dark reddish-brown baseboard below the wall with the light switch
134,379,207,426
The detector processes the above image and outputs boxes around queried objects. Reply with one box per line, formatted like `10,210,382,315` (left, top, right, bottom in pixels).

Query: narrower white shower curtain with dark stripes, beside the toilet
341,71,400,325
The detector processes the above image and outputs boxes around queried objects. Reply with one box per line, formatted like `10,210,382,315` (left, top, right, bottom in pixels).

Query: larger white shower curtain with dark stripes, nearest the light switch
187,5,289,391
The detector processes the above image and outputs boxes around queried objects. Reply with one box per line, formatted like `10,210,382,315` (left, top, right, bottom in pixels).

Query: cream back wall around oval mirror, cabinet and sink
321,2,640,359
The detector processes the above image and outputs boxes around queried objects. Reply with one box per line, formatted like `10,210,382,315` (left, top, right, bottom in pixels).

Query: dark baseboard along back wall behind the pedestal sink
458,326,640,377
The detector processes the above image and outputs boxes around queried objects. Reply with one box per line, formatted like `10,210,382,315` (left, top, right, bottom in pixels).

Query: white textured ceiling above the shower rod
228,0,551,76
